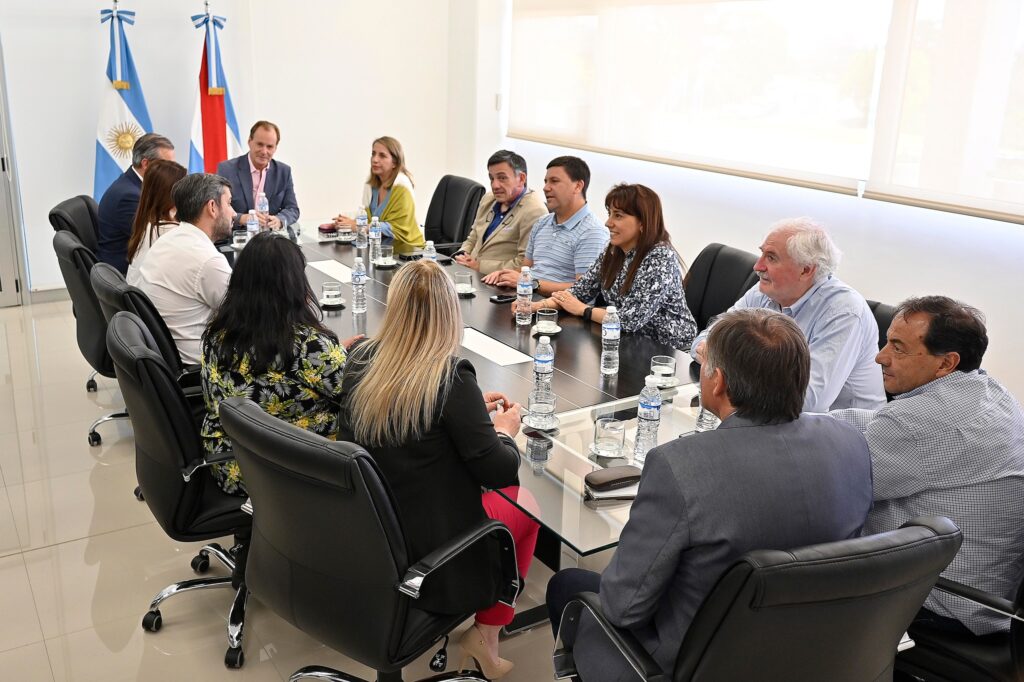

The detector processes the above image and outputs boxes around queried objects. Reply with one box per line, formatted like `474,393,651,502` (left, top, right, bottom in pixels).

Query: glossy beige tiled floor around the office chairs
0,302,569,682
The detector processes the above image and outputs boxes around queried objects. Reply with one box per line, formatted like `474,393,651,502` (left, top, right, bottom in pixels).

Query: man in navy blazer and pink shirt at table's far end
217,121,299,229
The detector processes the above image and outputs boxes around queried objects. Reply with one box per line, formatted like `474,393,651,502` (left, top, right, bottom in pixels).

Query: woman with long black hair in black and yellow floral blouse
201,232,355,495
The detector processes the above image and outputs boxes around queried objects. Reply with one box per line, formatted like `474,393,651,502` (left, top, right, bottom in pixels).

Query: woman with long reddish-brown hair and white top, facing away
125,159,188,287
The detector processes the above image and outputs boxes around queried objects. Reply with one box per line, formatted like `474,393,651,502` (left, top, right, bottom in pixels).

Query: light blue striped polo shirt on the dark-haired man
525,204,608,282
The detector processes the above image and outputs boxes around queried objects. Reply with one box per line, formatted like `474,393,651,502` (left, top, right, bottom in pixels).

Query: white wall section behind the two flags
0,0,252,291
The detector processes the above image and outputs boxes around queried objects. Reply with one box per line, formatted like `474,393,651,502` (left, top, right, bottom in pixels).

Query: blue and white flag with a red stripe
188,10,243,173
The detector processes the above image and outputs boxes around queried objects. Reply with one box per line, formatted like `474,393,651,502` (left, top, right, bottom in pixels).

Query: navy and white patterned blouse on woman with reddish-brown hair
569,242,697,350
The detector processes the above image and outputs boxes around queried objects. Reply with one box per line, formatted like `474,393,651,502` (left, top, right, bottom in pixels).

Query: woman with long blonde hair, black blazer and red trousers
338,260,538,679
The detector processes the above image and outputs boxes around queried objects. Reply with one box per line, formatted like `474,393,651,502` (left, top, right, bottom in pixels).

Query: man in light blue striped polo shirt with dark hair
483,157,608,296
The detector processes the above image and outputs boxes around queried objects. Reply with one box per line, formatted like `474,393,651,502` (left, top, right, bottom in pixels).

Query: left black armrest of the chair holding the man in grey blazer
552,592,669,682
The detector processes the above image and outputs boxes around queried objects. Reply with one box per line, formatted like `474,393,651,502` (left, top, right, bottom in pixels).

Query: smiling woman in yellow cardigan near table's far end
334,136,425,253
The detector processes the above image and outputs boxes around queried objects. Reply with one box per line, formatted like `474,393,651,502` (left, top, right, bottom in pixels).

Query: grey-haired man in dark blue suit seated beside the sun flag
96,133,174,274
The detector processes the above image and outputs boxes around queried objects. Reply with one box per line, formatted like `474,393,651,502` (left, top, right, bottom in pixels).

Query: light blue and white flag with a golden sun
92,9,153,202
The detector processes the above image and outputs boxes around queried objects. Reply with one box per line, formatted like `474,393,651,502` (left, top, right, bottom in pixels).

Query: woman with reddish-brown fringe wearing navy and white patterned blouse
531,183,697,350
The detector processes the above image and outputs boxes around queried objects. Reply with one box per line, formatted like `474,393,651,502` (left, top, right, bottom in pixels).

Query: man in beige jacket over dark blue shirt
455,150,548,274
